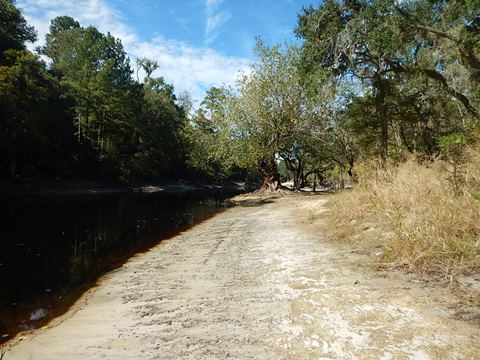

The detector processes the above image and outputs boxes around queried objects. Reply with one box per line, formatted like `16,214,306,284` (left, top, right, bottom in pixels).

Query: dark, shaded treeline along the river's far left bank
0,0,226,182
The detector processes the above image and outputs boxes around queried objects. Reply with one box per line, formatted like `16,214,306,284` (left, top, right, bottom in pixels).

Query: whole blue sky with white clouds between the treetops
17,0,319,103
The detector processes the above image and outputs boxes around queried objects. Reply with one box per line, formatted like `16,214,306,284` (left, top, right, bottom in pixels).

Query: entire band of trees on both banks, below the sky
0,0,480,190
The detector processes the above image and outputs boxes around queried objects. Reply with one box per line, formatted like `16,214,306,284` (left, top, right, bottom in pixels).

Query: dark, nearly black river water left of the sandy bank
0,190,233,343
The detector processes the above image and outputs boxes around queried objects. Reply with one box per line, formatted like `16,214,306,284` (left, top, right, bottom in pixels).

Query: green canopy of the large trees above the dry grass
296,0,480,176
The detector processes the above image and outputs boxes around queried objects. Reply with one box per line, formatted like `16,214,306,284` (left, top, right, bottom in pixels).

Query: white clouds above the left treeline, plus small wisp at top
17,0,249,102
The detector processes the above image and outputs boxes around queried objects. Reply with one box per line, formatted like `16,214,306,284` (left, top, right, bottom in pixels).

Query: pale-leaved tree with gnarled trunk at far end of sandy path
228,40,313,189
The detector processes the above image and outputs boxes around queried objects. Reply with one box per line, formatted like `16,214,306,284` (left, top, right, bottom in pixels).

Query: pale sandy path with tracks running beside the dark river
4,197,480,360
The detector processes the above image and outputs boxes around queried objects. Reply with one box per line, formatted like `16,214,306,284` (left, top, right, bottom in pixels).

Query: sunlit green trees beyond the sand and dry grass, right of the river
194,0,480,189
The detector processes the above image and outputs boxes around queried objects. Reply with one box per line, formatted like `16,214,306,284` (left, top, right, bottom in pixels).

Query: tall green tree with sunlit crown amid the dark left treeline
42,17,142,176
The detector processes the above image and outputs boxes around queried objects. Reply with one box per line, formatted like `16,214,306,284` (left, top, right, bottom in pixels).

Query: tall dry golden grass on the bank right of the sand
330,149,480,279
